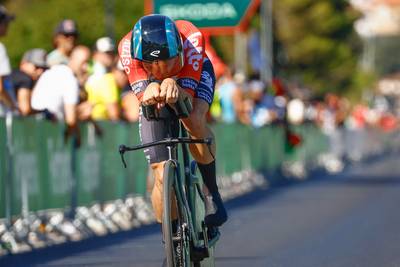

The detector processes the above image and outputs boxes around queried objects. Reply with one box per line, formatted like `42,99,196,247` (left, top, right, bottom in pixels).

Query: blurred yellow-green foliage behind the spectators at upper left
2,0,144,67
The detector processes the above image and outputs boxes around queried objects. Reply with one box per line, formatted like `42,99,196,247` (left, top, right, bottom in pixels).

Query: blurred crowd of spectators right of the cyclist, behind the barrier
211,69,400,133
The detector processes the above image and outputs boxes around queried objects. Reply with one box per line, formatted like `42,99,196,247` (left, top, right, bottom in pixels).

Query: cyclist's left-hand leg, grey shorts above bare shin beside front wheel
139,109,179,223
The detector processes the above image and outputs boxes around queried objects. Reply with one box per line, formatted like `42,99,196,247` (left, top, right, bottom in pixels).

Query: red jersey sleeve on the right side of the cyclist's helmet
175,20,205,95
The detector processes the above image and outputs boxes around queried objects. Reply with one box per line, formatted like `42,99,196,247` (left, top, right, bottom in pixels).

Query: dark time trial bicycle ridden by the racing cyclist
119,99,220,267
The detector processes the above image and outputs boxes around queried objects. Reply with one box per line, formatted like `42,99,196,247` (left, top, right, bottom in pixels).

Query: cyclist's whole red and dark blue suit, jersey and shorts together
118,20,216,163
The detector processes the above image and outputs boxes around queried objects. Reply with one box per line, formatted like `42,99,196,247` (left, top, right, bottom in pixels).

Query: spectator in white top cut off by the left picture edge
0,5,16,116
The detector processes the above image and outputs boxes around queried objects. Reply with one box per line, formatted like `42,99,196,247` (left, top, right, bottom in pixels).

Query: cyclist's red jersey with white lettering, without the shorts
118,20,209,103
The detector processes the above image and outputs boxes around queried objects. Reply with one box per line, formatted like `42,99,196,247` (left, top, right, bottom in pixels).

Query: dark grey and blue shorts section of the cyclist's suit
139,60,216,164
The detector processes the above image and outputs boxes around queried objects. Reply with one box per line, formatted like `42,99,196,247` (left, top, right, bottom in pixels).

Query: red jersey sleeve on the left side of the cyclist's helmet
118,31,149,101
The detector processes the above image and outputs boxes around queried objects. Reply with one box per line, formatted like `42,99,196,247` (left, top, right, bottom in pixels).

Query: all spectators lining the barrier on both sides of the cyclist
0,6,400,138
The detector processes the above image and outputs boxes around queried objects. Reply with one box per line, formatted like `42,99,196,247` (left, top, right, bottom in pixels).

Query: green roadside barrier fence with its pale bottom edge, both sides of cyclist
0,116,400,256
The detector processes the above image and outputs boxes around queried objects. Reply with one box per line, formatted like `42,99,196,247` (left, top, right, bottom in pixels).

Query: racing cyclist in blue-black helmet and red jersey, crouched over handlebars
118,14,227,226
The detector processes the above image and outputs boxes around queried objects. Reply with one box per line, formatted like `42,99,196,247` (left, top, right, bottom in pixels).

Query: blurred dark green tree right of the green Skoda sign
274,0,368,96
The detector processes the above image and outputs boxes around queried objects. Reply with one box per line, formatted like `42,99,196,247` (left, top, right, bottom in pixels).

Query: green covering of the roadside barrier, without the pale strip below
0,118,328,222
